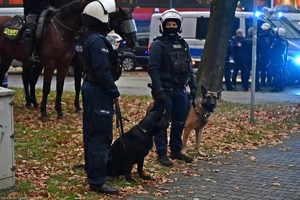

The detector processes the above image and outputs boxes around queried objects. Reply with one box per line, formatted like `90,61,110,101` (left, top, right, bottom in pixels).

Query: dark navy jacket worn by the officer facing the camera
148,36,196,91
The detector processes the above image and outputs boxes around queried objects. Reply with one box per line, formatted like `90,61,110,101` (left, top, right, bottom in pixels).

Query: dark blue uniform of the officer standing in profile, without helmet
82,33,120,185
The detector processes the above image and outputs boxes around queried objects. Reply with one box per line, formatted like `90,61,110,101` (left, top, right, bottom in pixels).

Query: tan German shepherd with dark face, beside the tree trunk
182,87,221,152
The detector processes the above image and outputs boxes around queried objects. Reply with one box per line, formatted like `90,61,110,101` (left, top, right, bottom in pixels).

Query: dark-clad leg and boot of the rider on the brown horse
23,0,49,57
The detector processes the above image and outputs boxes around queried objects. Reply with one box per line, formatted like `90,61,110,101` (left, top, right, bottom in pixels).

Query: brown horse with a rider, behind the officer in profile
0,0,135,120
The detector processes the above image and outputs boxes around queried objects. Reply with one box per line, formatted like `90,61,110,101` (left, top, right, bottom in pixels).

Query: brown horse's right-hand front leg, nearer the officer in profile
55,64,69,119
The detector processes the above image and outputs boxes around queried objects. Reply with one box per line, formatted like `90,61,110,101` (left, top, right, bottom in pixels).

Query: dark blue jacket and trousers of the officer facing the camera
148,35,196,157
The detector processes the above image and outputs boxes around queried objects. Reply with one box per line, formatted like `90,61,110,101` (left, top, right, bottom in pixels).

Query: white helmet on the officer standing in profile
82,0,117,23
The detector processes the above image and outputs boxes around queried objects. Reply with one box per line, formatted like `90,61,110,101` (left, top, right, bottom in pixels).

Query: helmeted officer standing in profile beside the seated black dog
82,0,120,194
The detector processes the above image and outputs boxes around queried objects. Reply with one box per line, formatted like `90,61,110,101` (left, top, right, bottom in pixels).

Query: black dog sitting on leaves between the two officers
108,107,167,182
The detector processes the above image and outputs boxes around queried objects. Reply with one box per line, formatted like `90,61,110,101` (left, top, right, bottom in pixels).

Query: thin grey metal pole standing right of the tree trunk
250,0,257,124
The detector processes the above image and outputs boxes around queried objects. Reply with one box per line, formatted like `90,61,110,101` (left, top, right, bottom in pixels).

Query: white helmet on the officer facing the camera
159,9,182,32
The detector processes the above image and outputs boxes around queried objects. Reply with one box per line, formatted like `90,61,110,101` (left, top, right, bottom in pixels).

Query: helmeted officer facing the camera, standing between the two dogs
148,9,196,166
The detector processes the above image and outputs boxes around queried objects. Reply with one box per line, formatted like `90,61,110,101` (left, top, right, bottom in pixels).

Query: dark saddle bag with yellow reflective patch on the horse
3,15,25,40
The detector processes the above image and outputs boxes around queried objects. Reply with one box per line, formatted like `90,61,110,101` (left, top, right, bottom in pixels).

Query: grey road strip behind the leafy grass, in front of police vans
8,74,300,104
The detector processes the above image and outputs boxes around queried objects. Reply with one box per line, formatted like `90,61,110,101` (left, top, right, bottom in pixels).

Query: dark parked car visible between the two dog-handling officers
120,33,149,71
